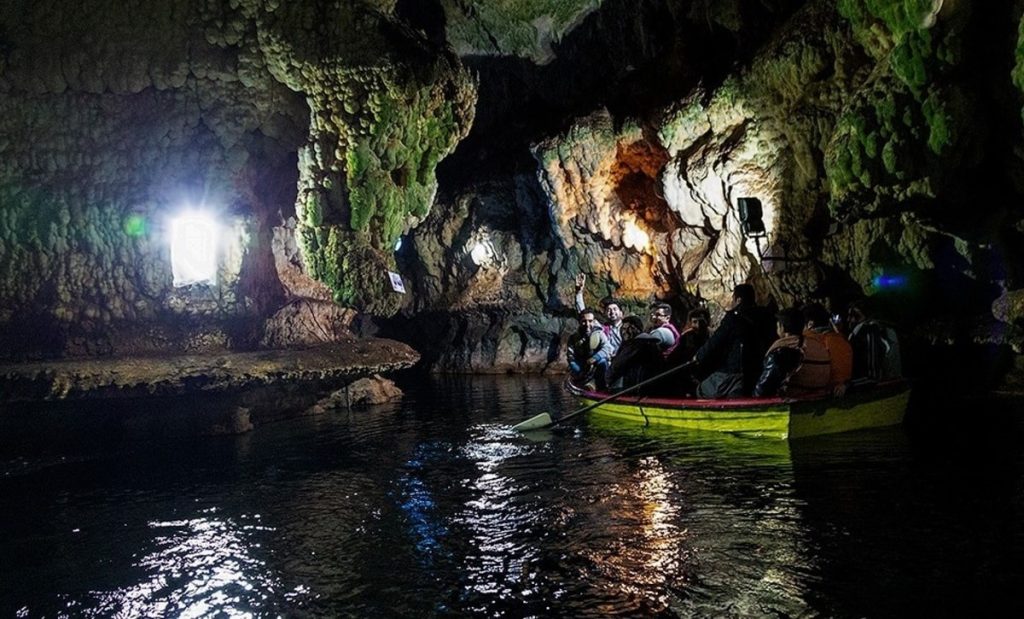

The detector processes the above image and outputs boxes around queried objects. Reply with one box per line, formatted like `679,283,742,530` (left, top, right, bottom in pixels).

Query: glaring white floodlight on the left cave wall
171,211,219,286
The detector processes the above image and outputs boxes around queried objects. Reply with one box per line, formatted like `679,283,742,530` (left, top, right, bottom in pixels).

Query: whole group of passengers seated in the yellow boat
567,274,901,399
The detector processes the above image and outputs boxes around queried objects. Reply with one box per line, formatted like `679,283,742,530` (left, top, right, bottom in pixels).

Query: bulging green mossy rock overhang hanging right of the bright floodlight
260,4,475,315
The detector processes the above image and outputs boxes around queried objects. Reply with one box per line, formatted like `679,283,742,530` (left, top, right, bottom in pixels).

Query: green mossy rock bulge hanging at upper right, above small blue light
825,0,976,217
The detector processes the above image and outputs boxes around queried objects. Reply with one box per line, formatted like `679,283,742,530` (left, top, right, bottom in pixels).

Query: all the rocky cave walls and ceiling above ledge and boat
0,0,1024,381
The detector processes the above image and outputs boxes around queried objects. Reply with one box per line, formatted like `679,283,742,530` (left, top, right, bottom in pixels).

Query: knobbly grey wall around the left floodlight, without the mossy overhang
0,2,305,357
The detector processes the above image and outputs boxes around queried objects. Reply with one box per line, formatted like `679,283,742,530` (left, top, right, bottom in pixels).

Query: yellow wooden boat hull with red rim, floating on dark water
567,380,910,439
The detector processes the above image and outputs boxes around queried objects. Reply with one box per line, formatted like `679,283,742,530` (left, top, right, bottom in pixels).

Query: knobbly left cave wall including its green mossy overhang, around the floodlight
0,0,474,359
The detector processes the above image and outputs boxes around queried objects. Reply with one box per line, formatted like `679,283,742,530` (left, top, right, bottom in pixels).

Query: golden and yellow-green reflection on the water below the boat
587,415,814,616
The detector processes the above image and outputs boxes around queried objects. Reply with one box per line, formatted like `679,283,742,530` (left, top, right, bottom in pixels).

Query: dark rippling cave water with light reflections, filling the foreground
0,377,1024,617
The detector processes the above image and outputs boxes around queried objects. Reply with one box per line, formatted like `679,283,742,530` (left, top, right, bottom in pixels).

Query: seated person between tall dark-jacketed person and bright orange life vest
754,307,831,398
